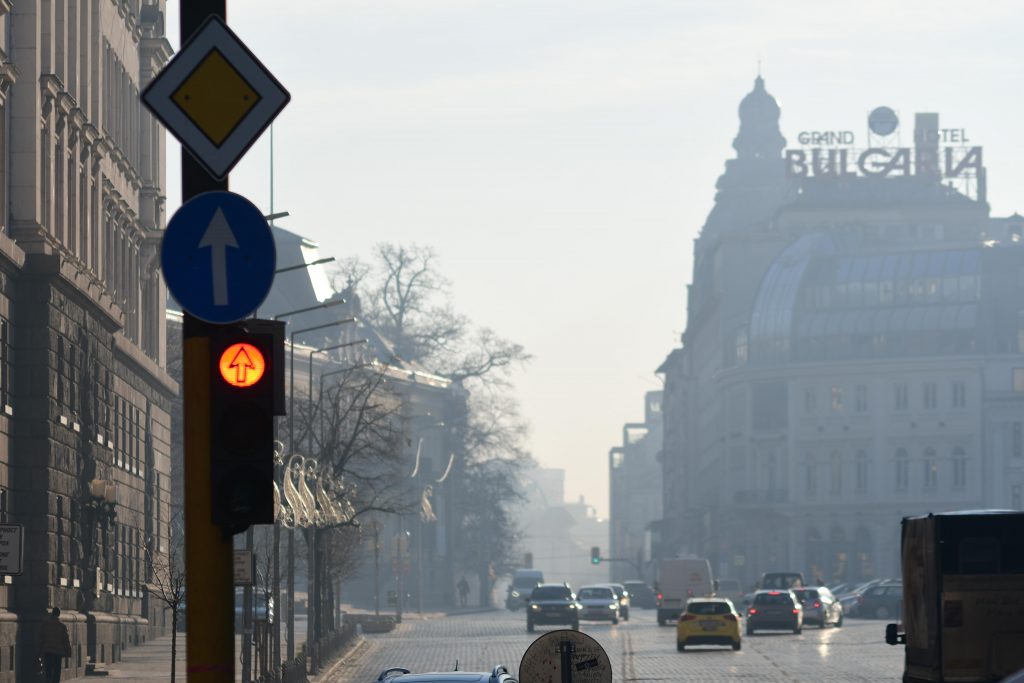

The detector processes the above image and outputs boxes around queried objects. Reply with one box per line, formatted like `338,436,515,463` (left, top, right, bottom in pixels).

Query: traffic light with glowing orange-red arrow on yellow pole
208,319,285,533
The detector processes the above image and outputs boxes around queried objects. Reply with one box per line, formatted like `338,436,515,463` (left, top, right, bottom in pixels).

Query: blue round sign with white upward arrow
160,191,278,325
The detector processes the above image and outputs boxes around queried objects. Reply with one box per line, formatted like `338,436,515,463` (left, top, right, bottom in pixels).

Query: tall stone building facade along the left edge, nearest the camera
0,0,177,681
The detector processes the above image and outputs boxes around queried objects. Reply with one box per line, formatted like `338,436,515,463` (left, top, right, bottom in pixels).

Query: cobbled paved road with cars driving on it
330,610,902,683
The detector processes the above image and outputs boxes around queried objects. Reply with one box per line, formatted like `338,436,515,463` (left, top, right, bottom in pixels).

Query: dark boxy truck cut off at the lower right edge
886,510,1024,683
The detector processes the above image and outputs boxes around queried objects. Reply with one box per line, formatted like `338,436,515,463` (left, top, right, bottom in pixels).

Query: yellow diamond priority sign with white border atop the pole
142,16,291,178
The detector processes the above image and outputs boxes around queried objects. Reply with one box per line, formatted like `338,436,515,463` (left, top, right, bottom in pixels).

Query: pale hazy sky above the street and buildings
161,0,1024,515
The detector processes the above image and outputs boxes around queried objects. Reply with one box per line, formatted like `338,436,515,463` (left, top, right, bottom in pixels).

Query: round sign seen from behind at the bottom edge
519,630,611,683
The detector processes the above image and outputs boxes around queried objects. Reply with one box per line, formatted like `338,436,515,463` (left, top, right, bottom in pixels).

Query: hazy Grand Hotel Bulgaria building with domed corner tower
660,78,1024,584
